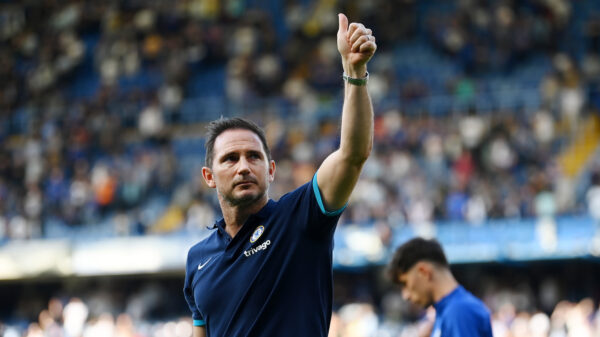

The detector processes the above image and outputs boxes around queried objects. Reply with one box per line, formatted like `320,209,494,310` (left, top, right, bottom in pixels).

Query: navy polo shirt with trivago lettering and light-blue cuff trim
184,174,343,337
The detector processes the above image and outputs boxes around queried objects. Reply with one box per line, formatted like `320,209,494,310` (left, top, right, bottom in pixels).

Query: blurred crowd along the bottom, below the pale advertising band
0,285,600,337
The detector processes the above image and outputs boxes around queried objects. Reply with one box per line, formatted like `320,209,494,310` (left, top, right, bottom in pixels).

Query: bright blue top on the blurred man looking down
431,285,492,337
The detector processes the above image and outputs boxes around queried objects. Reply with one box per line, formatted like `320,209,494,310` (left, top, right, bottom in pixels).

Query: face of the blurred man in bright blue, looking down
398,262,433,308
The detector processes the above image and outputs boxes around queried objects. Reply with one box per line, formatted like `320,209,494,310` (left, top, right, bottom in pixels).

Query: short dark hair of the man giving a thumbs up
204,117,271,167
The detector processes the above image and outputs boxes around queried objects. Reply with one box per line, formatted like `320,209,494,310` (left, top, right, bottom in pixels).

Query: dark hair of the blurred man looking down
387,238,449,282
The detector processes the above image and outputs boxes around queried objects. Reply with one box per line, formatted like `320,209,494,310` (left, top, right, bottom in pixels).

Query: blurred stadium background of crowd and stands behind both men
0,0,600,337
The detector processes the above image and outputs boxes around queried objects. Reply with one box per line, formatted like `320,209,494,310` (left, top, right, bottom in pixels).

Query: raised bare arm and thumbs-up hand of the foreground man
317,14,377,211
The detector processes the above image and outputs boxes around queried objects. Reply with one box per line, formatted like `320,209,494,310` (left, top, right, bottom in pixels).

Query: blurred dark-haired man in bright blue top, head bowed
388,238,492,337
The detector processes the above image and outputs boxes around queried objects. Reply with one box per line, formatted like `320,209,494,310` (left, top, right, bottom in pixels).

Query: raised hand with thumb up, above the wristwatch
337,13,377,78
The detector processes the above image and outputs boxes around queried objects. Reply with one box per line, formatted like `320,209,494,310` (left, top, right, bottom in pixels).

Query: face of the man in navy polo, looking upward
202,129,275,206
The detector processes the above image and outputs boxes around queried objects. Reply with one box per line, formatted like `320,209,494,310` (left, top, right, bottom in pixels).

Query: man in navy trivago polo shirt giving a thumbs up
184,14,377,337
